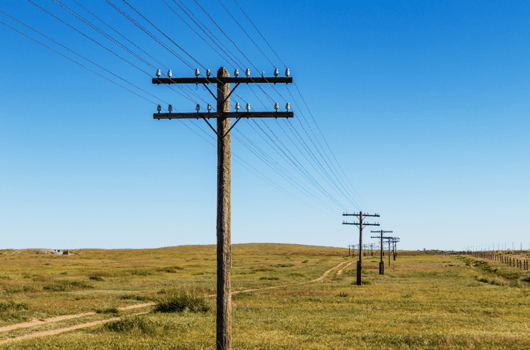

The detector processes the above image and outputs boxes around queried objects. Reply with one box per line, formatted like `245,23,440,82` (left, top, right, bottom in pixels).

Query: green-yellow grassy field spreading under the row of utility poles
0,244,530,349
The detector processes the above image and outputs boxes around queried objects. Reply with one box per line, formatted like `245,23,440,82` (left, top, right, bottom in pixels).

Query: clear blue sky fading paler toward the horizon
0,0,530,249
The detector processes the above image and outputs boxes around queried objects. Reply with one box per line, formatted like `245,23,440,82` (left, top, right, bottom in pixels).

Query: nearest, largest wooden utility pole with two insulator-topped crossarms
152,67,293,350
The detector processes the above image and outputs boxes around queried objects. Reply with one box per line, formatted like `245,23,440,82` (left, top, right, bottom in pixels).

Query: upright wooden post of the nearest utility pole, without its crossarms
216,67,232,350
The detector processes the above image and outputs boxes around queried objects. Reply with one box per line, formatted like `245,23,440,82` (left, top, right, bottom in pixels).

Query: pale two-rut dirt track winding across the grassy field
0,261,354,345
